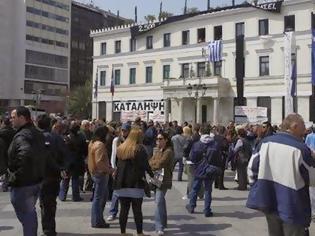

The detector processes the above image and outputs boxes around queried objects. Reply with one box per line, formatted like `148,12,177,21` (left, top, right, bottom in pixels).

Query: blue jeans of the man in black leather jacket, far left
11,184,40,236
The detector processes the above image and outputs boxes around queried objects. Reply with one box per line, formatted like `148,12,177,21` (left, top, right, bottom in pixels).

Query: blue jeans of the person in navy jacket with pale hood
189,177,214,214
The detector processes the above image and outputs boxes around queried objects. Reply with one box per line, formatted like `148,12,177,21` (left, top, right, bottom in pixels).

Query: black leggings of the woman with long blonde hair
119,197,143,234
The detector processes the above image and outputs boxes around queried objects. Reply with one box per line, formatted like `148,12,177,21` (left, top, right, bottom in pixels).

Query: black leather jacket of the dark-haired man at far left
8,123,46,187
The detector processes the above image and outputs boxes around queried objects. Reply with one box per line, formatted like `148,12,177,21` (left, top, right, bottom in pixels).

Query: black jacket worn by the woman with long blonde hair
114,146,153,189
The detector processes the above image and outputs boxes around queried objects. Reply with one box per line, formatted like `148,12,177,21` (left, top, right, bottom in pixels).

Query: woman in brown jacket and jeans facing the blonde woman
150,133,174,235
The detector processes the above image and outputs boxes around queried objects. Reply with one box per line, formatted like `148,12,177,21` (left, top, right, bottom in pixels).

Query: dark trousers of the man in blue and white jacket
266,214,308,236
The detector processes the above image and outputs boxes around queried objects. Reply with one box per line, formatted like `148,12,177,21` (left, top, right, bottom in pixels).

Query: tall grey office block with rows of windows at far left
0,0,71,113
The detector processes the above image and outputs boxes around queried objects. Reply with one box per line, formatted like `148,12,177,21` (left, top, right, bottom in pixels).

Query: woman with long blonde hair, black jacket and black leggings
114,127,153,235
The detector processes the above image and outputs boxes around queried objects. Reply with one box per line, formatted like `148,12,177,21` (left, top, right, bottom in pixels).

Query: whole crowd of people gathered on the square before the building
0,107,315,236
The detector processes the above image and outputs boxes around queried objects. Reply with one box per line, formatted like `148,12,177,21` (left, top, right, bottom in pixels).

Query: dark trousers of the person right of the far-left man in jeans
39,179,60,236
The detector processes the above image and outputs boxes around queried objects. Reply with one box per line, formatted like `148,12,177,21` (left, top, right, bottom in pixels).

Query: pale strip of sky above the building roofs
76,0,244,21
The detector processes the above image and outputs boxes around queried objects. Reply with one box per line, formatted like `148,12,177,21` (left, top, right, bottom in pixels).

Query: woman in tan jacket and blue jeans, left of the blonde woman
88,126,113,228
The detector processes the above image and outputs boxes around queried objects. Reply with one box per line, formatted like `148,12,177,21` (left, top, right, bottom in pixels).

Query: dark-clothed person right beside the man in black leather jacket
37,114,66,236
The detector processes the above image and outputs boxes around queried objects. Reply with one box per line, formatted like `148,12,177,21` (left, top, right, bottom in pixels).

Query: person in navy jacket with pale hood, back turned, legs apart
186,127,221,217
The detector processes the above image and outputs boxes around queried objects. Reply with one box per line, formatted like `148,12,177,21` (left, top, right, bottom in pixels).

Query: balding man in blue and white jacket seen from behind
246,114,315,236
